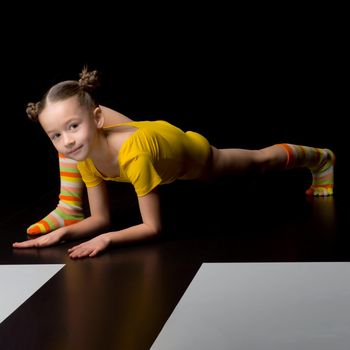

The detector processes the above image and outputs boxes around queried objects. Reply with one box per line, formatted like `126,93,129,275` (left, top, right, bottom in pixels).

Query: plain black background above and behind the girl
0,4,349,216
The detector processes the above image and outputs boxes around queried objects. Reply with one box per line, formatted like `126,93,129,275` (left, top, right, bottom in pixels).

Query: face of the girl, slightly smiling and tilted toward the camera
39,96,100,161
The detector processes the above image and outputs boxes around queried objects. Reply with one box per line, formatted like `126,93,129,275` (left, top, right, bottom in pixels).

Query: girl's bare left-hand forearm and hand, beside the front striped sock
13,182,110,248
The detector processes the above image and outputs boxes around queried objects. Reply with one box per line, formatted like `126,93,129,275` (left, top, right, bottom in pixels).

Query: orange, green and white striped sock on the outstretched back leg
277,143,335,197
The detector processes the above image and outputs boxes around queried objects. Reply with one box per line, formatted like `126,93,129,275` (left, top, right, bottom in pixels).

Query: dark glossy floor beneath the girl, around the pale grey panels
0,172,350,350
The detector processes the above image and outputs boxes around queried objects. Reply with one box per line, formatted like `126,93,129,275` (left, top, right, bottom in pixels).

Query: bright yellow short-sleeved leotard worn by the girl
78,120,211,197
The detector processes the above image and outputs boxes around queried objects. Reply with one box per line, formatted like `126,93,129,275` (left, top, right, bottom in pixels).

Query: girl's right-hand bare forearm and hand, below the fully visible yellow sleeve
68,190,161,258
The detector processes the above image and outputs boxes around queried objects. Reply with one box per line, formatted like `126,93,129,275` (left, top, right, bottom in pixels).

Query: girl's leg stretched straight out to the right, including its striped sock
212,144,335,196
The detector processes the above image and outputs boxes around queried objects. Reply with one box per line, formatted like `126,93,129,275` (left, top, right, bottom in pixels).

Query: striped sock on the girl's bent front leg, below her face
27,154,84,235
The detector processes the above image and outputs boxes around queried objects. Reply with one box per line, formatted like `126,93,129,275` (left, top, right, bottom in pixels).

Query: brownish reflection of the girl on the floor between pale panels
61,246,169,349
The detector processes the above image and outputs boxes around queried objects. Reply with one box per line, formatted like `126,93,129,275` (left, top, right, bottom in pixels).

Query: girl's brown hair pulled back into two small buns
26,66,100,122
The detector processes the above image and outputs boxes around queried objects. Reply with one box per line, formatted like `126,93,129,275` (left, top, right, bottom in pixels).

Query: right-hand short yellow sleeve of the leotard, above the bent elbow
124,154,162,197
